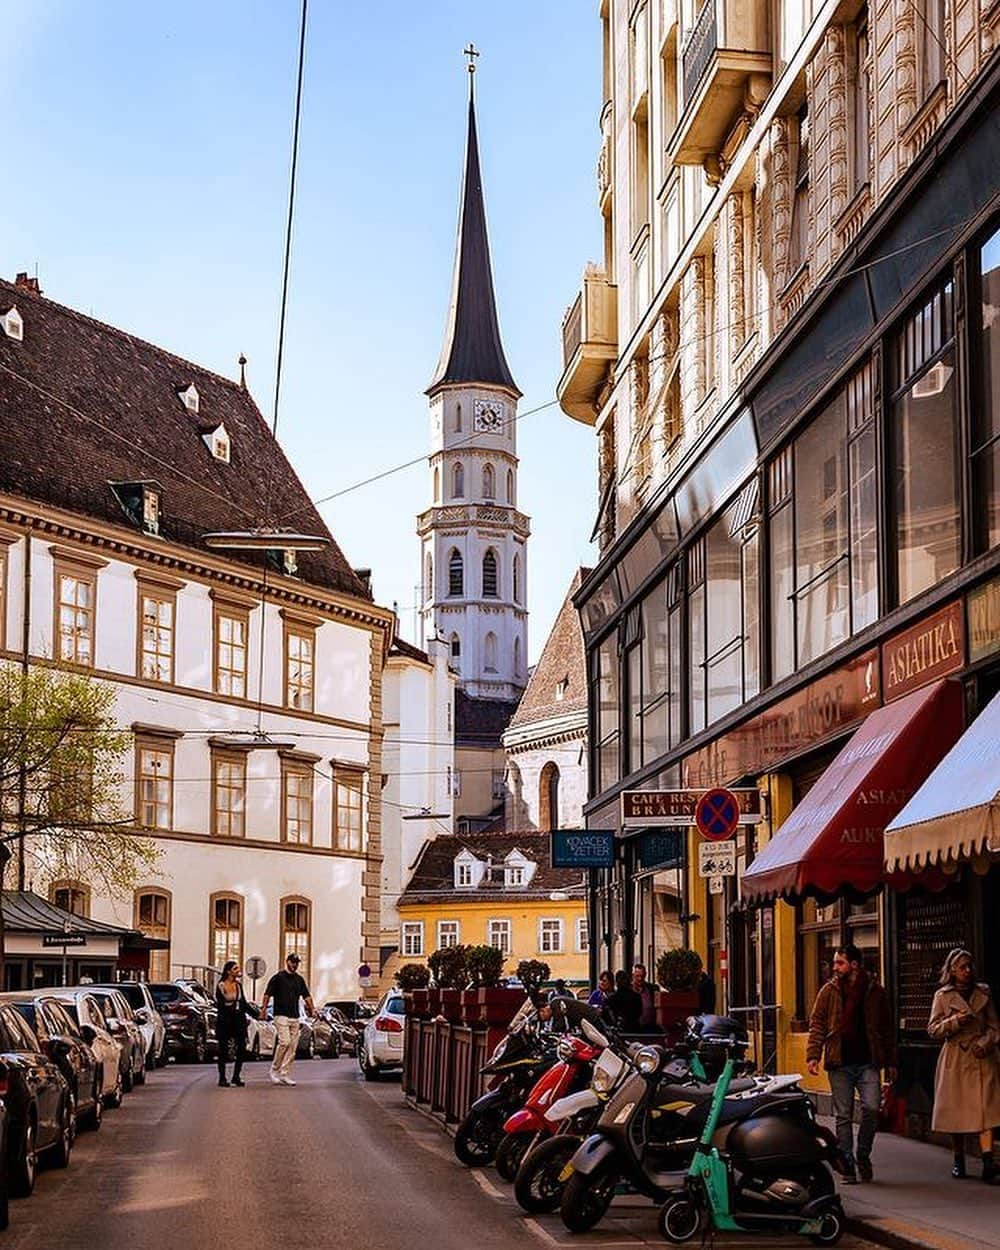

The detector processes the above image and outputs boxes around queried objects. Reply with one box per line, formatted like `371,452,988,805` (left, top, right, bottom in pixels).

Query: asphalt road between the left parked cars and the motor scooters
0,1059,885,1250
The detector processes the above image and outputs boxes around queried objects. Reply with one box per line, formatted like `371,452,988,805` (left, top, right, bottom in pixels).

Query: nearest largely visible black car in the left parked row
0,1003,76,1198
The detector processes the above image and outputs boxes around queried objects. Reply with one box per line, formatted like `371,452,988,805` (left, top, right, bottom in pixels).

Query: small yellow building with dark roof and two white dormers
399,833,589,984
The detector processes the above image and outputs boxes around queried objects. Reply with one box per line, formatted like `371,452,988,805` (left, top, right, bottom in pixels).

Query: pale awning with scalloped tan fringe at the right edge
885,695,1000,873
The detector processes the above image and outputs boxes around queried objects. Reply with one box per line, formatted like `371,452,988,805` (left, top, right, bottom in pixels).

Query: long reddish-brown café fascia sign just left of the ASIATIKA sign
681,650,881,789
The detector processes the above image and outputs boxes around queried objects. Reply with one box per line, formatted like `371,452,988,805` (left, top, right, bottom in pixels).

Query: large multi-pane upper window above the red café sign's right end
768,364,879,680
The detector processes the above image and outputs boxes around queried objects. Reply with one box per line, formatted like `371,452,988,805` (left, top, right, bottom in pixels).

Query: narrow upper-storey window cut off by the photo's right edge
971,230,1000,551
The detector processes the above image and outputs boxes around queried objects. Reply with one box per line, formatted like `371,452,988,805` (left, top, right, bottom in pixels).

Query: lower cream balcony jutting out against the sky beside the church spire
556,265,618,425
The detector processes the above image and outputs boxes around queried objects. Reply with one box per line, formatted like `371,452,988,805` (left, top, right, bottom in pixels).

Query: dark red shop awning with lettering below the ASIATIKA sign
741,681,963,903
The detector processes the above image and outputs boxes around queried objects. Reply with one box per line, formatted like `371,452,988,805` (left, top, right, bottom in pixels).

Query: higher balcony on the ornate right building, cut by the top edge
670,0,771,165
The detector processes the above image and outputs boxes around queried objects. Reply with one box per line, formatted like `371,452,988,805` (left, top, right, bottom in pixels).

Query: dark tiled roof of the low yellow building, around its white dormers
399,833,586,904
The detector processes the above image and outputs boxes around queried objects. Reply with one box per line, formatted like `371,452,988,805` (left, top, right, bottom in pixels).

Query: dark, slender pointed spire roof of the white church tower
428,95,521,395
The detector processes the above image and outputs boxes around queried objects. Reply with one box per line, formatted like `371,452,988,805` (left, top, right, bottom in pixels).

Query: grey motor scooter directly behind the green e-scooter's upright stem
560,1016,806,1233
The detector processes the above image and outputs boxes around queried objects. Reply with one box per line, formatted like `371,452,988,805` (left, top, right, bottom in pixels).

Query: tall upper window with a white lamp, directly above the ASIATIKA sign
891,283,961,604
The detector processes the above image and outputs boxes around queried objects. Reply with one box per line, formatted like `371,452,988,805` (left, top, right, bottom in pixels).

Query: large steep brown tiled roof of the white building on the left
0,280,371,600
